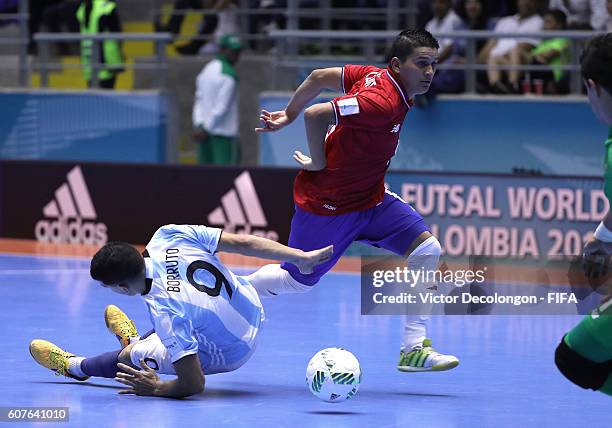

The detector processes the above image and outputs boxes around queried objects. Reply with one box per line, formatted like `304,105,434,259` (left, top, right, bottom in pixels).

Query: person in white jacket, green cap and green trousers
192,34,242,165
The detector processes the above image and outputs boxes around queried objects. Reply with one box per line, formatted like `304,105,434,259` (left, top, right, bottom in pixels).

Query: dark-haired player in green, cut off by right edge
555,33,612,395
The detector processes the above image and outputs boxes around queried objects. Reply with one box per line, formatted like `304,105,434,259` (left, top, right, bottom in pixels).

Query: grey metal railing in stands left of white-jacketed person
34,33,172,89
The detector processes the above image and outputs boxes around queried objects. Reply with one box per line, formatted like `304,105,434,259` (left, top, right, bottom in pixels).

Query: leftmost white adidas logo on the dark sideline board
34,166,108,245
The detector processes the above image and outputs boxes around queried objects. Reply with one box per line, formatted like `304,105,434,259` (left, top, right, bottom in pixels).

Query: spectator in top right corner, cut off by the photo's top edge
548,0,606,30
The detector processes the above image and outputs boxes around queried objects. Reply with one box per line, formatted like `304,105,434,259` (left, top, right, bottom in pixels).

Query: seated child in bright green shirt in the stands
515,9,570,95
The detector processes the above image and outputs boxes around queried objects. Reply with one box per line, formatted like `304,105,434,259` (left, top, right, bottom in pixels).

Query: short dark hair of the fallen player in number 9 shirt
89,242,145,284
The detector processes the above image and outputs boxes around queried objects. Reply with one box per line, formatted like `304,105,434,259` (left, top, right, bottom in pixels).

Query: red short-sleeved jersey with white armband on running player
293,65,412,215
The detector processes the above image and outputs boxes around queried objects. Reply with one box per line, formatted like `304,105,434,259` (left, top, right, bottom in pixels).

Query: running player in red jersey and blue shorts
256,30,459,372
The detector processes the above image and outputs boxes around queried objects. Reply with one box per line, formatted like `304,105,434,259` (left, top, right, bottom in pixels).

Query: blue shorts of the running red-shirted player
281,192,429,285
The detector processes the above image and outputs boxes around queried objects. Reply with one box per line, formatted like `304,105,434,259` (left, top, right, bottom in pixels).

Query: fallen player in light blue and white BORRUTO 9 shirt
30,225,333,398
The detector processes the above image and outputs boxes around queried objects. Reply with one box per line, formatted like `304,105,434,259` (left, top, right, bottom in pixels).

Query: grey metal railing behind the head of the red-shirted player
270,30,598,94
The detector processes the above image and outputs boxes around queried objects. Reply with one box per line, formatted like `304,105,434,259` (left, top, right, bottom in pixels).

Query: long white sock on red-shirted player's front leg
401,236,442,352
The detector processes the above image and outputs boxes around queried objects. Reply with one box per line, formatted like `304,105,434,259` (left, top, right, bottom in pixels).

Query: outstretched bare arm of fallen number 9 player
217,232,334,273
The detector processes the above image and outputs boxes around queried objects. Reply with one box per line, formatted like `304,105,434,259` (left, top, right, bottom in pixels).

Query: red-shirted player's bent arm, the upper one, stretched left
255,67,342,132
